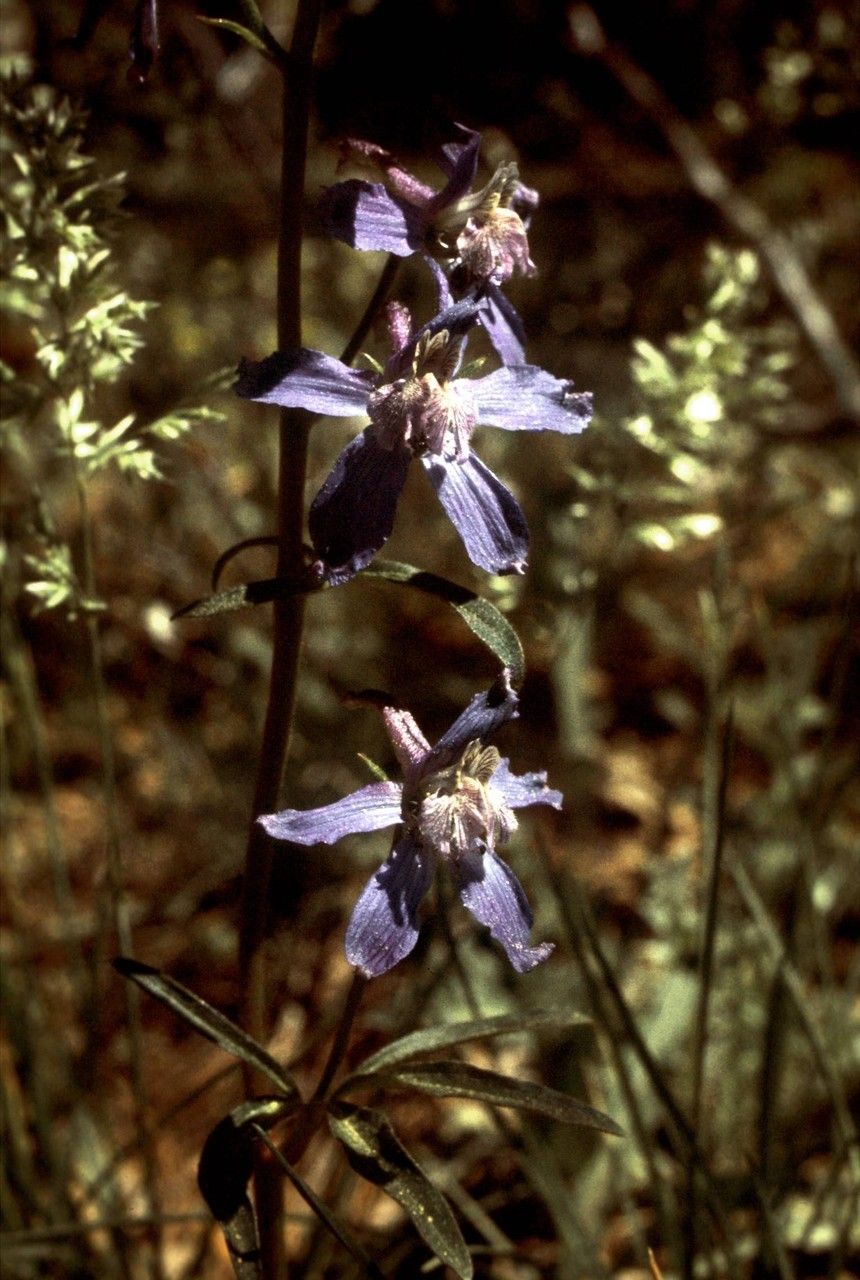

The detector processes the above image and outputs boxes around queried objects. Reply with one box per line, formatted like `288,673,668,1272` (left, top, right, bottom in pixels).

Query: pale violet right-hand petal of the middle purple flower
474,365,591,435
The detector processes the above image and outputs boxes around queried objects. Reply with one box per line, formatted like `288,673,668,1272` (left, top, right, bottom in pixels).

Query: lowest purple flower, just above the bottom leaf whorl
260,672,562,978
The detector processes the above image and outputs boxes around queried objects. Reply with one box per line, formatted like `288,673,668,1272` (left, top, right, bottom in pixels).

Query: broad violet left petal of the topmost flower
321,178,427,257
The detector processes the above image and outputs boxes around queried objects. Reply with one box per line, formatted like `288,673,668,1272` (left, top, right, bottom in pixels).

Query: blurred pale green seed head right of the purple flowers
557,244,795,591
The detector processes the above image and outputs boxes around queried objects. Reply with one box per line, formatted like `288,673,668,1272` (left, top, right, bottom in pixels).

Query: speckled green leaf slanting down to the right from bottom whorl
329,1102,472,1280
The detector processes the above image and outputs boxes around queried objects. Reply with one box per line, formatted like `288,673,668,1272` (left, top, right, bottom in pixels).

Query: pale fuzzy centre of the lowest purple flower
412,742,517,858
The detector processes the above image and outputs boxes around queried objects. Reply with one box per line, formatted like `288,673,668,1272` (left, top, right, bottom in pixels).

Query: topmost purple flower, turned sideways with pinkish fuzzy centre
323,125,539,365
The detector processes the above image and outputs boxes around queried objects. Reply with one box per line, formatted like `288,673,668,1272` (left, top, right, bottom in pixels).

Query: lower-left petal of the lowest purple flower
346,835,435,978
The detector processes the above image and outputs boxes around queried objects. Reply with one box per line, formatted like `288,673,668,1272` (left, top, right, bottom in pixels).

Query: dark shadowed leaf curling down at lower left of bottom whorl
197,1098,296,1280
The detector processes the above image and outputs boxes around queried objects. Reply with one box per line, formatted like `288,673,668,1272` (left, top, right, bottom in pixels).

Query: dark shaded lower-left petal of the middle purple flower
308,429,412,584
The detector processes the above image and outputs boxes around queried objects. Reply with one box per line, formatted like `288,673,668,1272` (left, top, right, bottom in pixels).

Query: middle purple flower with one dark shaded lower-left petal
235,302,591,584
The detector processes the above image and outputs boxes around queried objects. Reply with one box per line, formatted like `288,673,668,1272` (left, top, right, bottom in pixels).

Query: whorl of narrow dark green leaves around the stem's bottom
114,957,622,1280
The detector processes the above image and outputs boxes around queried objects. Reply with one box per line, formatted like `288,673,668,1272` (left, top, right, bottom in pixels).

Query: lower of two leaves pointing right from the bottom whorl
353,1060,623,1137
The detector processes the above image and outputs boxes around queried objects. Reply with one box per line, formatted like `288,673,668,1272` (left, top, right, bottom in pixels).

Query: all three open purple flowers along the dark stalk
235,129,591,977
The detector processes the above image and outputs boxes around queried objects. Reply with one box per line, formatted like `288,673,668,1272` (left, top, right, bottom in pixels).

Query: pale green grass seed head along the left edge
0,70,220,614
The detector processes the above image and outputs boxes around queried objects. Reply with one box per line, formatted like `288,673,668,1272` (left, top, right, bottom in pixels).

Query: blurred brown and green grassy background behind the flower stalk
0,0,860,1280
